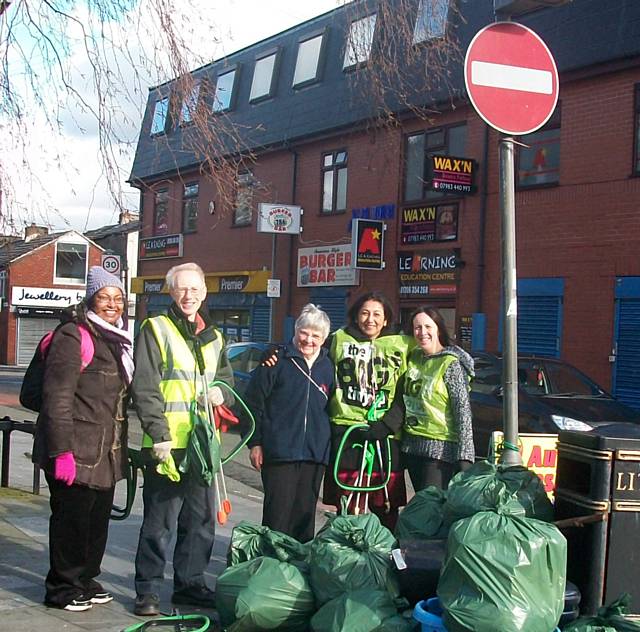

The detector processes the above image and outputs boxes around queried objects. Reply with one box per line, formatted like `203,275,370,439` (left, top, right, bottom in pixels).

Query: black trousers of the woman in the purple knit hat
45,474,115,608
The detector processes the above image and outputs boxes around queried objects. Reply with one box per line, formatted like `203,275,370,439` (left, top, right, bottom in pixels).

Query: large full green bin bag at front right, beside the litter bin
437,498,567,632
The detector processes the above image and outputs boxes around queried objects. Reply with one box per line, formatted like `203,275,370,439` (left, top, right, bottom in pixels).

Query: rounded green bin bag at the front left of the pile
216,557,316,632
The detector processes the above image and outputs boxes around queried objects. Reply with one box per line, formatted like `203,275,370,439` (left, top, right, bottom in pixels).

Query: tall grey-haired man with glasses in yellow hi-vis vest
132,263,233,615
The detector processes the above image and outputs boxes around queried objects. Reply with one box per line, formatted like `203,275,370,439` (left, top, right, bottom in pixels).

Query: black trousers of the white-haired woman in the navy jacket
261,461,324,542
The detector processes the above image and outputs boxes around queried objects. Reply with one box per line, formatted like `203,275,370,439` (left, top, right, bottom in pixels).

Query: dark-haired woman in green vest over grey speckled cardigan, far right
384,306,475,491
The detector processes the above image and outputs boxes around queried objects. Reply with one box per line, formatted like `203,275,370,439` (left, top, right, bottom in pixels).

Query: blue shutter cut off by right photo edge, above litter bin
612,277,640,410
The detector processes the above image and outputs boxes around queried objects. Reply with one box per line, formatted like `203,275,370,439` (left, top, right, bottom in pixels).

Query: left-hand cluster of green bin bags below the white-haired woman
216,514,419,632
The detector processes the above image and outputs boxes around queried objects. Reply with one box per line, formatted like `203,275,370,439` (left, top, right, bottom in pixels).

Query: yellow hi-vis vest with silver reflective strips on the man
142,316,222,448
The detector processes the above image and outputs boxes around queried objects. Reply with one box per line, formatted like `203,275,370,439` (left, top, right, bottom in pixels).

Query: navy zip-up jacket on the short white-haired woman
245,344,334,464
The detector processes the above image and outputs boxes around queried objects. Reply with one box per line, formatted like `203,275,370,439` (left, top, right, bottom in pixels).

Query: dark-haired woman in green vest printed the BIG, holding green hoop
323,292,413,530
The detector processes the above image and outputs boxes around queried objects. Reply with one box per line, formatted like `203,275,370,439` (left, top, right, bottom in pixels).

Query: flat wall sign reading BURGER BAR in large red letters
297,244,359,287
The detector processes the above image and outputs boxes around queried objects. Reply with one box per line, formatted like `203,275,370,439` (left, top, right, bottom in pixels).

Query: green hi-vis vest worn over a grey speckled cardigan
403,349,458,442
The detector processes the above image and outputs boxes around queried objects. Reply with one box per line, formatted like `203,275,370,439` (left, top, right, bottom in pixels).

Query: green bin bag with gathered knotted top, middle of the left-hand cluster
309,514,400,605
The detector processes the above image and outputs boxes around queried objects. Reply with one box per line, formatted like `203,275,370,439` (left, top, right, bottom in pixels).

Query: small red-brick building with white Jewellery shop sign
0,225,104,365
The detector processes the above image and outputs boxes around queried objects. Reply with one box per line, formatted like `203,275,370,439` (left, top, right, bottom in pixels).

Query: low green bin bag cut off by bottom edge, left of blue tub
311,589,396,632
